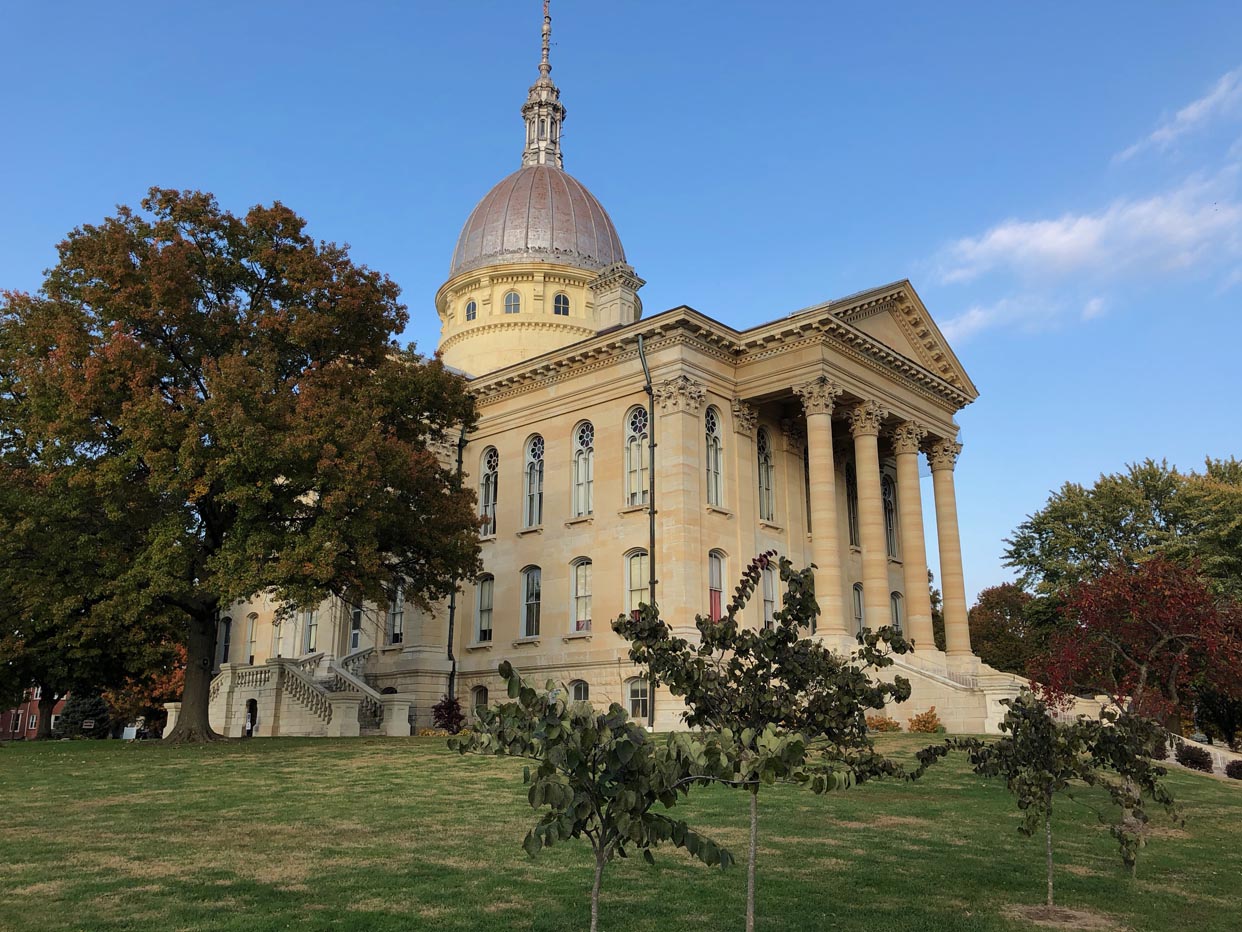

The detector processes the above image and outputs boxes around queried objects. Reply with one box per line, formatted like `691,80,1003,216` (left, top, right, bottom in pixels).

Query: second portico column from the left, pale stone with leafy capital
850,401,891,630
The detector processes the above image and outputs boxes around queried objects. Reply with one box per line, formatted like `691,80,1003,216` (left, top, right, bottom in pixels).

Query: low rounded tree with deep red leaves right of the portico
1028,557,1242,718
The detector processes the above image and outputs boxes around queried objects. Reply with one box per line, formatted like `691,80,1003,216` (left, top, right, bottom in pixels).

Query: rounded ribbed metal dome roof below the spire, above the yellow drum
448,164,625,278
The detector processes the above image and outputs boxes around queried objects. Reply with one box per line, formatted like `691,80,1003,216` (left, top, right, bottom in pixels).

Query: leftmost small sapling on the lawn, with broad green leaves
450,661,733,932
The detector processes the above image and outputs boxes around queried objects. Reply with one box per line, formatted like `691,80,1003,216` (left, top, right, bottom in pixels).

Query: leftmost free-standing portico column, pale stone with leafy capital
794,377,850,636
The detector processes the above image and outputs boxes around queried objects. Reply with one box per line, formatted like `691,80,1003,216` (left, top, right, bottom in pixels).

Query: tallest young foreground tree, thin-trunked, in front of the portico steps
612,553,938,932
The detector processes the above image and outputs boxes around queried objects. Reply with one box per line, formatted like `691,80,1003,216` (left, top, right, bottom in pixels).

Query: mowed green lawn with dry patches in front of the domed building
0,736,1242,932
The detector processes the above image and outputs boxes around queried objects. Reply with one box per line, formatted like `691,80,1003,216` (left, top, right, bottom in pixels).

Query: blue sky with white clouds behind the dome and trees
0,0,1242,596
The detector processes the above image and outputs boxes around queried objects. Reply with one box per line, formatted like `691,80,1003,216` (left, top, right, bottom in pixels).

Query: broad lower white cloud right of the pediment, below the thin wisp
939,169,1242,283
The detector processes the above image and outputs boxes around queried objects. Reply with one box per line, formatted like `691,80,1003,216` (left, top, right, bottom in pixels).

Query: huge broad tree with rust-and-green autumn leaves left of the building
0,189,478,741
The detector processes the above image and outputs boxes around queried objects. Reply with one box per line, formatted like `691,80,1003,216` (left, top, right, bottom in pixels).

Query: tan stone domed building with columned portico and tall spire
170,5,1018,736
